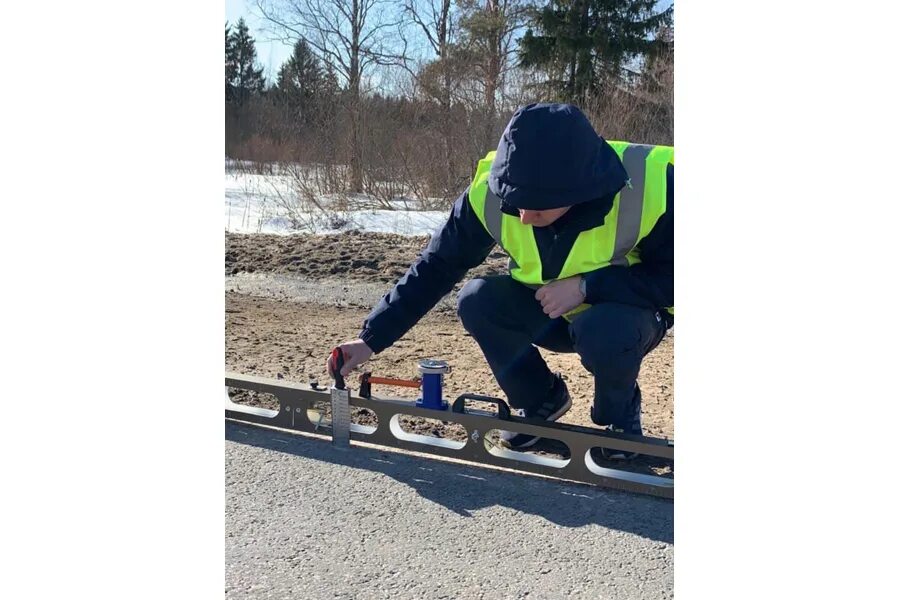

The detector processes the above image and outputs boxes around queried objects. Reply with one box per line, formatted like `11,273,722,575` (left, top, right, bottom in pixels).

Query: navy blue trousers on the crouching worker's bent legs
457,275,667,433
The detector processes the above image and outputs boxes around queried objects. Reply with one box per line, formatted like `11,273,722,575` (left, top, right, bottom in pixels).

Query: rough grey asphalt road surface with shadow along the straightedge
225,422,674,600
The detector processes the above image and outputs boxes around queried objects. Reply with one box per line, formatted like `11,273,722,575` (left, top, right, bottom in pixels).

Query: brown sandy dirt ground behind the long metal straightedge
225,232,674,472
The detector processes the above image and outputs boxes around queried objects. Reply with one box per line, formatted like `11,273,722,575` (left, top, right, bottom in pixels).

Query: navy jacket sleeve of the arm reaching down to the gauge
359,191,494,353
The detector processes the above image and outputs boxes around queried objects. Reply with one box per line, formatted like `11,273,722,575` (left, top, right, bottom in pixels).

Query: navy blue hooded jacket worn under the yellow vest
360,104,675,352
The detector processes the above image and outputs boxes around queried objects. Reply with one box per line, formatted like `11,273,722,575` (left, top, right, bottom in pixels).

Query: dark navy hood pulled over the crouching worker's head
488,104,628,210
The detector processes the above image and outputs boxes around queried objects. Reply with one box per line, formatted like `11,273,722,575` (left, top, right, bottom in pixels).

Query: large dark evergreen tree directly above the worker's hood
520,0,673,101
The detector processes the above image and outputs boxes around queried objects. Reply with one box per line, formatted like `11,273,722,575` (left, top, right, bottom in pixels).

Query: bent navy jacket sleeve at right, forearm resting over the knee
585,166,675,309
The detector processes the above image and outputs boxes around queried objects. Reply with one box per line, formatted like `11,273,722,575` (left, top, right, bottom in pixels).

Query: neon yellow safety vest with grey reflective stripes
468,142,675,318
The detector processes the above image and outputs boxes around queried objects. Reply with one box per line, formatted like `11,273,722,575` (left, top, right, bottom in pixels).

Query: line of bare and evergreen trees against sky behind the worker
225,0,674,199
